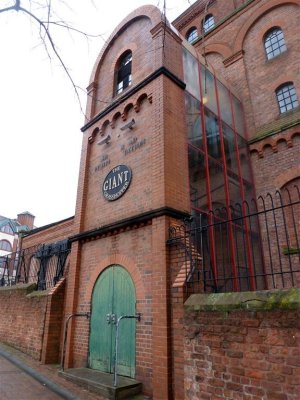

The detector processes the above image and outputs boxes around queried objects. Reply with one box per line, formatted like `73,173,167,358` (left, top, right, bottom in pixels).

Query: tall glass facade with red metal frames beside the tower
183,49,254,290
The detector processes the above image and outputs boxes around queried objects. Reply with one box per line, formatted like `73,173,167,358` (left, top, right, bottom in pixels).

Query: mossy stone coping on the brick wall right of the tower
184,288,300,312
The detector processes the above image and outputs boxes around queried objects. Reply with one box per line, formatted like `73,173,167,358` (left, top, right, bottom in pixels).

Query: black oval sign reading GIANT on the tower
102,165,132,201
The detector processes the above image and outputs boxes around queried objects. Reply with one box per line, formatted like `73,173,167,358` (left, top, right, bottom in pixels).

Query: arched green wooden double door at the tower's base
89,265,136,378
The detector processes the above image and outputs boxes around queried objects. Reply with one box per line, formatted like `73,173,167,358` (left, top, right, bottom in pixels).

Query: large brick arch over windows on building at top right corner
233,0,300,54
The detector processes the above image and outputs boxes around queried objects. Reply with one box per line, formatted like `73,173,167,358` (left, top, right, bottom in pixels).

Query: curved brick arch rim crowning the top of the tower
90,5,161,84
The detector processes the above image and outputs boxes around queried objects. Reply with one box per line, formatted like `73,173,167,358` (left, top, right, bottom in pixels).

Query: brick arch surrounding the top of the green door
86,254,145,300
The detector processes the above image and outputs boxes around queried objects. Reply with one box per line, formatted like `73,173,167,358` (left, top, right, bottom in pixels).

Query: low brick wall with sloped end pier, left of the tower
0,281,64,363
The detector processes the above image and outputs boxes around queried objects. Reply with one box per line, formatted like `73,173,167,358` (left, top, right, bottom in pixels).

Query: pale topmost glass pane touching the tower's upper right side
183,48,200,100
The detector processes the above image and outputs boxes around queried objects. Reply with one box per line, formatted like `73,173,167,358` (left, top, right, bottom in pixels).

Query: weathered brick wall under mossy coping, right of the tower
184,311,300,400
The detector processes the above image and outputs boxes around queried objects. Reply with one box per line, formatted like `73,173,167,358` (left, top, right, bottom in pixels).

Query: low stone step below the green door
59,368,142,400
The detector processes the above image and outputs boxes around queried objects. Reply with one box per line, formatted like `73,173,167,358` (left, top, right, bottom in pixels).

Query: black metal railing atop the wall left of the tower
0,240,70,290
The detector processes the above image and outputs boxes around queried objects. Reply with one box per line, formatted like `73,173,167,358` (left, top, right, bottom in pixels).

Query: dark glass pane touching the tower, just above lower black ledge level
189,146,208,210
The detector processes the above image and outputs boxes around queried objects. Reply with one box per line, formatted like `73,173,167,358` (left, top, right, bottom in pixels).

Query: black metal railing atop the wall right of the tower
168,186,300,293
